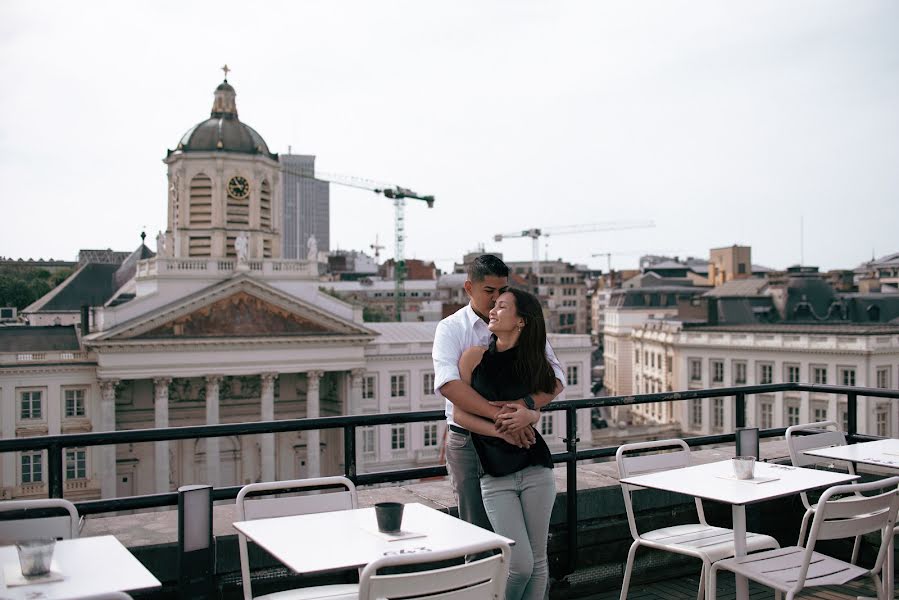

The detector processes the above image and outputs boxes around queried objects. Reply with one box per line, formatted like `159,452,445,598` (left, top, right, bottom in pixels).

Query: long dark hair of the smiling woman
509,288,556,393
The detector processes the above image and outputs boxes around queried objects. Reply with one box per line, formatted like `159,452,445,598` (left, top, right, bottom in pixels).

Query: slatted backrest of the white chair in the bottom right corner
799,477,899,586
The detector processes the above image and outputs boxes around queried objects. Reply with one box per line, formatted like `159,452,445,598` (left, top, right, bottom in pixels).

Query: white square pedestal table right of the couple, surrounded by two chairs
621,460,858,600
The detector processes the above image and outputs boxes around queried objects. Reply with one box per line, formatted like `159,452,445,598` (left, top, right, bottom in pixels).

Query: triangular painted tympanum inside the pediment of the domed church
139,292,336,339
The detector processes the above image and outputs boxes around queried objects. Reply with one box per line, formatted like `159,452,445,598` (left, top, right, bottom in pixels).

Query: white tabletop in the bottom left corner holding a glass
0,535,162,600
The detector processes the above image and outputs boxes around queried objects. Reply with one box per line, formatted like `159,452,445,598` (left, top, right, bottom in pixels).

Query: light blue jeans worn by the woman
481,467,556,600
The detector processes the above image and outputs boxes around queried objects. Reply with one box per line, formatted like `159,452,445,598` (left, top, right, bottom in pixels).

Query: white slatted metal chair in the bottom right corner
708,477,899,600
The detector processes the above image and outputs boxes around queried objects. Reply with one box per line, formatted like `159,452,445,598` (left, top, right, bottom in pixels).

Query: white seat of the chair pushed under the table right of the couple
640,523,778,562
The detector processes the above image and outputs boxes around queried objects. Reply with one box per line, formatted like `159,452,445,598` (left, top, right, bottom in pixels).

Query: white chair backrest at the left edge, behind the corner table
0,498,81,544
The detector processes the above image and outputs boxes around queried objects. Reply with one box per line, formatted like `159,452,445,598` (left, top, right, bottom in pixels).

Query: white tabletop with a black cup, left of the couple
234,503,514,573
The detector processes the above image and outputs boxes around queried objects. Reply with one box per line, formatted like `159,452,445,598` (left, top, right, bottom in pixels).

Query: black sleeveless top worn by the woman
471,335,553,477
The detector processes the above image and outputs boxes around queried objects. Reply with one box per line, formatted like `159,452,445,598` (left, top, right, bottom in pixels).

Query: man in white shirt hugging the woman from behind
432,254,564,529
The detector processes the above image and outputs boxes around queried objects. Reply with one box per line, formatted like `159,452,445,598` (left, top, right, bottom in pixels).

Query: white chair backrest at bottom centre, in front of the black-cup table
359,540,510,600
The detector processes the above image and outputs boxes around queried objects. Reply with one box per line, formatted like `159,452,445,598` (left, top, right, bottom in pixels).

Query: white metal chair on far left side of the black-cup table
236,476,359,600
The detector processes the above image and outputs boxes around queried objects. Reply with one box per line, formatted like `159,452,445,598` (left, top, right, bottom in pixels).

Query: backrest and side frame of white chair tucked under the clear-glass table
615,439,706,540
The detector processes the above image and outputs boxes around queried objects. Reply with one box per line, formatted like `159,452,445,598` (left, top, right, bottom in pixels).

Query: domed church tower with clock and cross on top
161,66,281,260
